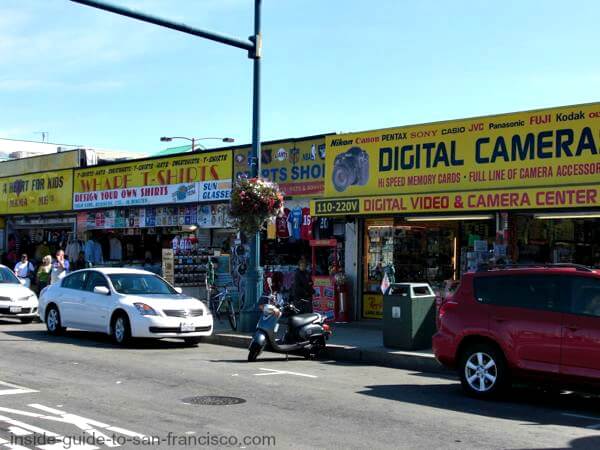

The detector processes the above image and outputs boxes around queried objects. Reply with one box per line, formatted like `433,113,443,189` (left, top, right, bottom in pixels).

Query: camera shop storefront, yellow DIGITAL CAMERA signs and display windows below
311,104,600,318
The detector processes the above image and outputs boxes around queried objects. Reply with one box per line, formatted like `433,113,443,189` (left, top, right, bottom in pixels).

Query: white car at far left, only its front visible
0,265,38,323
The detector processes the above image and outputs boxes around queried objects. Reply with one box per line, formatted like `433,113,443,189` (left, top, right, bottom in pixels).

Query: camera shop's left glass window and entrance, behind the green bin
363,218,494,318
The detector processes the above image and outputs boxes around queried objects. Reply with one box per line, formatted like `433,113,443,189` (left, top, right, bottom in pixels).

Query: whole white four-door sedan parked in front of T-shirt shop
39,268,213,345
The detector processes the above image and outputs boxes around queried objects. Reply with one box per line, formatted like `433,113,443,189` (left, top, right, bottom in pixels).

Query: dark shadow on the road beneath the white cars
0,324,192,350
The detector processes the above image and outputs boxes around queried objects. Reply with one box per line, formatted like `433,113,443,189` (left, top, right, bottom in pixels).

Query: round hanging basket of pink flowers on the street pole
229,178,283,236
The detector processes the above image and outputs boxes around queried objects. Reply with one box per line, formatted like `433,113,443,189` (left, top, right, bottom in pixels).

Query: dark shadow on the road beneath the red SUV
358,383,600,430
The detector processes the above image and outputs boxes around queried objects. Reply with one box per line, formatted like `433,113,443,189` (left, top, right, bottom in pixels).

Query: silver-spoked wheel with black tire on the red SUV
459,344,508,398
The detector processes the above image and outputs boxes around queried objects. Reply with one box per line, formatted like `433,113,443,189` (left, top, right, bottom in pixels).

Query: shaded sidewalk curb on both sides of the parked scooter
204,333,449,373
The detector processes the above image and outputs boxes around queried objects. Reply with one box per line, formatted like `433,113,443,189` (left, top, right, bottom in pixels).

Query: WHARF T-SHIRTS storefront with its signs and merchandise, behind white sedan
73,151,235,298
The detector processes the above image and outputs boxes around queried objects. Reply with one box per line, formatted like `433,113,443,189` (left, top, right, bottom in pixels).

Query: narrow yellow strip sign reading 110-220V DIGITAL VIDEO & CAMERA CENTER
310,184,600,216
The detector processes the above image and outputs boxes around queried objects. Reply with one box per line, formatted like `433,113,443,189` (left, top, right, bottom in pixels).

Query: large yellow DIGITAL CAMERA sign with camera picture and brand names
325,103,600,197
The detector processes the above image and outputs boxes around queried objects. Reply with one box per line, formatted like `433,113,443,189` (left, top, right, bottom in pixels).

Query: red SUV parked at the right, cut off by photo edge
433,265,600,397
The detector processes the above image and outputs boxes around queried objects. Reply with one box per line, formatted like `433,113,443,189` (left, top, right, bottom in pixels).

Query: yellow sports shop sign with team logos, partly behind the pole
234,136,325,197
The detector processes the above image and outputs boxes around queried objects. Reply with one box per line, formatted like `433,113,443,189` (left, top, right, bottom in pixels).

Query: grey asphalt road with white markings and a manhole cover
0,321,600,450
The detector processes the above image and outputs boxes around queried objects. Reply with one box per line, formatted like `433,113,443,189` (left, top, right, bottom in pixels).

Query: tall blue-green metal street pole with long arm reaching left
71,0,262,331
